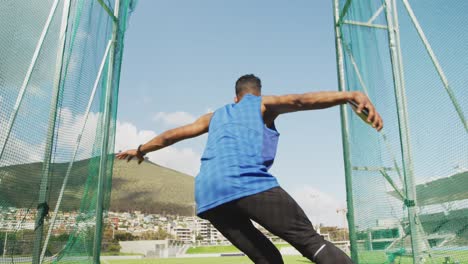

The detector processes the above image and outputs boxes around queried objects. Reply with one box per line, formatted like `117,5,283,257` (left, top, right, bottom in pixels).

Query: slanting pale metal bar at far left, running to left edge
0,0,59,161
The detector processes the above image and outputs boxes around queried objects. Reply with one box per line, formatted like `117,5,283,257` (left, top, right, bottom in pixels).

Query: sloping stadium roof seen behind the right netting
388,171,468,206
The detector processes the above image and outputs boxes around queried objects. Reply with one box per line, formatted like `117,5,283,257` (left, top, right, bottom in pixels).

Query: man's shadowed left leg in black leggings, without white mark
200,204,284,264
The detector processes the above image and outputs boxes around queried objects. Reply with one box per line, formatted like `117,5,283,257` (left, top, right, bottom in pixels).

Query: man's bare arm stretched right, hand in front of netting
262,91,383,131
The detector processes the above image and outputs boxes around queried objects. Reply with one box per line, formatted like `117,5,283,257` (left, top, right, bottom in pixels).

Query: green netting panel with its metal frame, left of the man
0,0,134,263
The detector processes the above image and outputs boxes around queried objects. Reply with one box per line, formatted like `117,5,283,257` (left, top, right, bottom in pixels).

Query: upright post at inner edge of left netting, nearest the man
93,0,120,264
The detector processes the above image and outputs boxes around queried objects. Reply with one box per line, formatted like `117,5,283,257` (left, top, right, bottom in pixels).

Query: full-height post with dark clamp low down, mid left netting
32,0,70,264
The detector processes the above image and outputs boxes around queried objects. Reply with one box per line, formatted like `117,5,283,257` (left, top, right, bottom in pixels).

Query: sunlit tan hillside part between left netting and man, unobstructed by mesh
111,160,195,215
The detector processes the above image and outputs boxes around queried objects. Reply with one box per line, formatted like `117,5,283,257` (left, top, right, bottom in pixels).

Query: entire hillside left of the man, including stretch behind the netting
0,160,195,215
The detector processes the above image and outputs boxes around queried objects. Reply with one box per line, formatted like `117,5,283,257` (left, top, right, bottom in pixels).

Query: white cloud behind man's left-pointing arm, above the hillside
115,121,200,176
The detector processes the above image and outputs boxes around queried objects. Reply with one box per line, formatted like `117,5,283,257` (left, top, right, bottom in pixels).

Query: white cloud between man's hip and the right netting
291,185,347,227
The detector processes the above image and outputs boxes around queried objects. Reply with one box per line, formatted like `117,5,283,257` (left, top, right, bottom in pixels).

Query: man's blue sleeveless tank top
195,94,279,214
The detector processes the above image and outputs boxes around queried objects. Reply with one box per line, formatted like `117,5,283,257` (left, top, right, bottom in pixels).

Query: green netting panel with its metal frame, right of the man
335,0,468,263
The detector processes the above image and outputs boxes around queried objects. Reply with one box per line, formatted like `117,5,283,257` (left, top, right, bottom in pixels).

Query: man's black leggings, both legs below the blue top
199,187,352,264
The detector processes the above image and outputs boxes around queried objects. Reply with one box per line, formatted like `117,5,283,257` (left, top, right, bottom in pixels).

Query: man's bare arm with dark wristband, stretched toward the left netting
116,113,213,164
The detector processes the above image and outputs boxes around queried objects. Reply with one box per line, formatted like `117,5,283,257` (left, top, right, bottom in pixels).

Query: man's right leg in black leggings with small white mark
234,187,352,264
